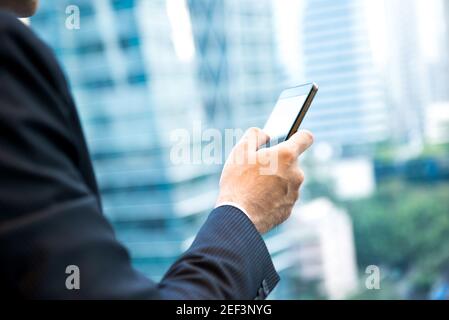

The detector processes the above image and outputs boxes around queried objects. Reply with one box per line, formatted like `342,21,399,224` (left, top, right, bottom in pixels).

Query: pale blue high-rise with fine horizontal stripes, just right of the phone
300,0,391,154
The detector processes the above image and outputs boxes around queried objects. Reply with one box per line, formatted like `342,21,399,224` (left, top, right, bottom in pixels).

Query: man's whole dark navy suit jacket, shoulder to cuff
0,12,279,299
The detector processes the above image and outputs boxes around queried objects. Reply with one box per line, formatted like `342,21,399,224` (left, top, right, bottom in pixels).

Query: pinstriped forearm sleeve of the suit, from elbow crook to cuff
160,206,279,299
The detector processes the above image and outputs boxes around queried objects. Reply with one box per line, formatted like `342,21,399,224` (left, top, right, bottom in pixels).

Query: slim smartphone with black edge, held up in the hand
263,83,318,146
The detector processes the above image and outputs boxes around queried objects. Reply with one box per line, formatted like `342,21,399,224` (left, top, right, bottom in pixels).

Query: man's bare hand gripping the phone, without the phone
217,128,313,234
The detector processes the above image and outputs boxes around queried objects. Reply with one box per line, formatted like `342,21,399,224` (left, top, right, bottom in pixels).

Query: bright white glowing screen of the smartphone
263,94,308,141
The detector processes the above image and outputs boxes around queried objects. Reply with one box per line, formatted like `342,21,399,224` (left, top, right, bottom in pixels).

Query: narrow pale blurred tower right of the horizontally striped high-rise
383,0,429,143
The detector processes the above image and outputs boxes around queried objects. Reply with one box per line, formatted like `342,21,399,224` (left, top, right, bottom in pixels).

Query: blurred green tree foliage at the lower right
345,180,449,298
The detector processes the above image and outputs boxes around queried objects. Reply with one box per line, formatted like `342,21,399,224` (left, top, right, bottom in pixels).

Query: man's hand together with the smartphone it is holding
217,83,318,234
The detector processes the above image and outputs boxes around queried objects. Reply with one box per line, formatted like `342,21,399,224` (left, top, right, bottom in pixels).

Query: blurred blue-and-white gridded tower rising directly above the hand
189,0,283,129
